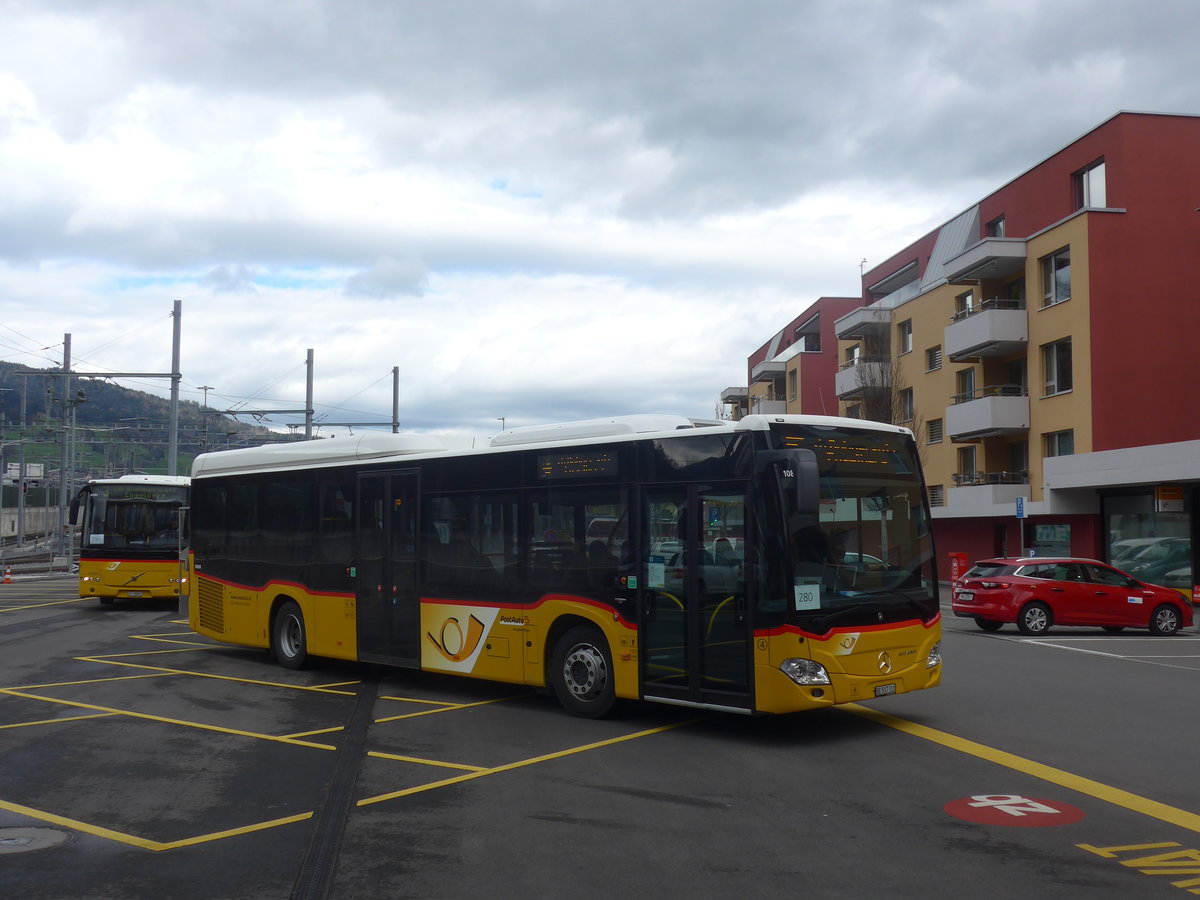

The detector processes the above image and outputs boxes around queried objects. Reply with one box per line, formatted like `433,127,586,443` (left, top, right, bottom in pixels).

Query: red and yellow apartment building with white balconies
724,113,1200,590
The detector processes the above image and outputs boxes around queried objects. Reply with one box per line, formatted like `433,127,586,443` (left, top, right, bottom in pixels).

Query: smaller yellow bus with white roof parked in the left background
71,475,190,604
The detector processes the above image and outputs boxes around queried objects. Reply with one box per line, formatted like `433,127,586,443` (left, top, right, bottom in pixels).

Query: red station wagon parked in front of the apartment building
952,557,1192,635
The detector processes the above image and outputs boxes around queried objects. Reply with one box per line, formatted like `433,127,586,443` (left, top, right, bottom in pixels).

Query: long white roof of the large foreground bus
192,414,911,478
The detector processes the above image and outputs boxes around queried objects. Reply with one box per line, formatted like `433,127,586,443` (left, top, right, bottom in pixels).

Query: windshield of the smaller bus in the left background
82,484,187,554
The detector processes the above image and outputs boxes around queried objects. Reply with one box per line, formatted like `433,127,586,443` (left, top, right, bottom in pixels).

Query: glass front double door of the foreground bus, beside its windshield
638,485,751,709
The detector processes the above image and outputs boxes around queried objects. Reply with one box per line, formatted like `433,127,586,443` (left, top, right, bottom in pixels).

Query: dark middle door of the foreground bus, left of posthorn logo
354,472,420,664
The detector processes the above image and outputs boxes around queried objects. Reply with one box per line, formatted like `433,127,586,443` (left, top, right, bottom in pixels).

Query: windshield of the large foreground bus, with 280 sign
773,424,938,632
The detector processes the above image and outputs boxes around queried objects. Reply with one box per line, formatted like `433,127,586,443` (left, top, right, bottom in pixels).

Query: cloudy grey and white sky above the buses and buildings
0,0,1200,437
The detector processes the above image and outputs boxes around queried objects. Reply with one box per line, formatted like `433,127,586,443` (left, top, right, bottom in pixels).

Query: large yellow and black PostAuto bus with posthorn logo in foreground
190,415,941,716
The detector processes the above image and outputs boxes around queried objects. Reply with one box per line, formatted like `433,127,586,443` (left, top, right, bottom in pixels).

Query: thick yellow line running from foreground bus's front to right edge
842,703,1200,832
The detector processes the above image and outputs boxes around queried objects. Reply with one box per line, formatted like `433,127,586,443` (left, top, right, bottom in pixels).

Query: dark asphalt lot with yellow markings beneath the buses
0,580,1200,898
